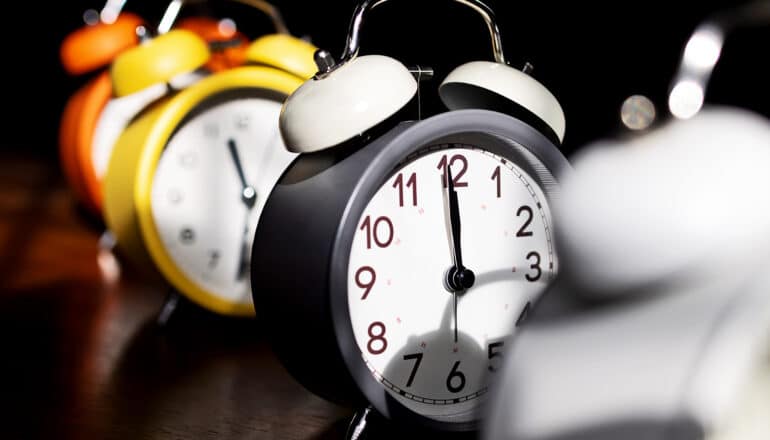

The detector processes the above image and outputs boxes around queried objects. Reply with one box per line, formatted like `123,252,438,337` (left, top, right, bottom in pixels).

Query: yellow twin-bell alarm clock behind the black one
104,4,316,317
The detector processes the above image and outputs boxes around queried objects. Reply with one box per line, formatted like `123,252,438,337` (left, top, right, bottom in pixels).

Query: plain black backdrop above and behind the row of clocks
6,0,770,161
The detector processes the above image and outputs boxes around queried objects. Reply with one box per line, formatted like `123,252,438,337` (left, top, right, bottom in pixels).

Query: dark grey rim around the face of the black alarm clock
329,109,571,431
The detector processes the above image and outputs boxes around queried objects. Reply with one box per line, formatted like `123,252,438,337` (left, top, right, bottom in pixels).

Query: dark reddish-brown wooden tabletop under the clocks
0,155,353,439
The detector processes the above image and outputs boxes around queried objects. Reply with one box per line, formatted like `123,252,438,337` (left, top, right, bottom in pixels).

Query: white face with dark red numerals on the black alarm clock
348,144,557,422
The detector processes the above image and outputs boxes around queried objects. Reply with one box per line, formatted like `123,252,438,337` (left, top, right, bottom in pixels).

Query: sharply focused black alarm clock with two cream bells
251,0,569,431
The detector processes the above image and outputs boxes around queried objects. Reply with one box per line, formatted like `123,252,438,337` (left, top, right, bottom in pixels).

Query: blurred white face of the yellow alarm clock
152,93,296,304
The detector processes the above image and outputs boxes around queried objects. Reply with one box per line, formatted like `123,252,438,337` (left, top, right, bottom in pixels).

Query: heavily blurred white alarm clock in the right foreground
482,2,770,440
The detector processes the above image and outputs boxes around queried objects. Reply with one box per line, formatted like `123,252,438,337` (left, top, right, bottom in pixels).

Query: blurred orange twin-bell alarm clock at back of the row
59,0,260,217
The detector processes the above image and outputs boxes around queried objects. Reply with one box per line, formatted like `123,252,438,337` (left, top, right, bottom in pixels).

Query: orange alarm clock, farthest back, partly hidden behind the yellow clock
59,1,255,217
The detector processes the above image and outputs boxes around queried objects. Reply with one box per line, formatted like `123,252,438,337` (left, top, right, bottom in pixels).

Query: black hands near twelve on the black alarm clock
444,164,476,343
